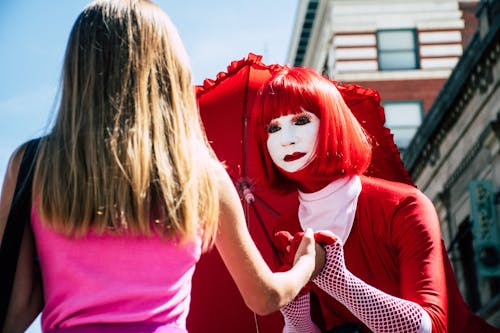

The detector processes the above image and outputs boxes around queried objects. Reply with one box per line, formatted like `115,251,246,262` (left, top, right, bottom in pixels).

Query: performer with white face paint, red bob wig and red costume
253,67,498,333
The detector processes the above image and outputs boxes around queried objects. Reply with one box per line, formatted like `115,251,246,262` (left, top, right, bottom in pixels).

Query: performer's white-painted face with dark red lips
267,110,319,172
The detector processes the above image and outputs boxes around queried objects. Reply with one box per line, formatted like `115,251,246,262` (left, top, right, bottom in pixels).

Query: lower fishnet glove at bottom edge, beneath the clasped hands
280,293,321,333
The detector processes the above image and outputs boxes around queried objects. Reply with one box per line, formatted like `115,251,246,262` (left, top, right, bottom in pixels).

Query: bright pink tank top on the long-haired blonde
31,204,201,332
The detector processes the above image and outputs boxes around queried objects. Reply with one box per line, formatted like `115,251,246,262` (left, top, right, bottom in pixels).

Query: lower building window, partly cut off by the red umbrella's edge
382,101,423,153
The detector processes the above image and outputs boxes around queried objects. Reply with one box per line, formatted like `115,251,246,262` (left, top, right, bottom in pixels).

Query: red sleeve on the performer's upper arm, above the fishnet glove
392,190,447,333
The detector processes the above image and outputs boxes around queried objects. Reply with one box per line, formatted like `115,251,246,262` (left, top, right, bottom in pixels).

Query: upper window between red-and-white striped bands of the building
377,29,419,71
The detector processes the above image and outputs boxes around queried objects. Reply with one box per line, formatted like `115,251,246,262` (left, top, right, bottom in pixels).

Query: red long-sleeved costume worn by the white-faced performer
278,176,498,332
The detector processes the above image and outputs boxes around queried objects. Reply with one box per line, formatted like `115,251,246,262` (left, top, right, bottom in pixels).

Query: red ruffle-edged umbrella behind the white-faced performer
188,54,412,333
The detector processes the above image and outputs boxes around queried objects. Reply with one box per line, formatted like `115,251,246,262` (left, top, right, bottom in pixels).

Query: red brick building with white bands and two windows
288,0,477,152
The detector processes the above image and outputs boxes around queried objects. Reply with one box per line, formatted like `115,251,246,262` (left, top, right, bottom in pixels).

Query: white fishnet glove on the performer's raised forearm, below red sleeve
313,239,430,333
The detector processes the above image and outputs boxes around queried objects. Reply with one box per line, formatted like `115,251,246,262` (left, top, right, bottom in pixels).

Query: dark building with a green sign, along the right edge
404,0,500,327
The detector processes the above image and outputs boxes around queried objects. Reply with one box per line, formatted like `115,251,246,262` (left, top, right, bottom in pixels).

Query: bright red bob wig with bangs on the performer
252,67,372,192
